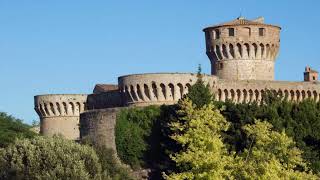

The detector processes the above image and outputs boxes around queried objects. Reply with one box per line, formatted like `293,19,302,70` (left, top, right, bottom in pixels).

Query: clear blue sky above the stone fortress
0,0,320,123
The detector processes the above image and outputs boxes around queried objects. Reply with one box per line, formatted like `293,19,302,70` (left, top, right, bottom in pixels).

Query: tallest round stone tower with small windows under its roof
203,17,281,80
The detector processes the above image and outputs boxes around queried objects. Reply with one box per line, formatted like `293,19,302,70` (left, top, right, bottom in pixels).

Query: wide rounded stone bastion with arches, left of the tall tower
119,73,217,106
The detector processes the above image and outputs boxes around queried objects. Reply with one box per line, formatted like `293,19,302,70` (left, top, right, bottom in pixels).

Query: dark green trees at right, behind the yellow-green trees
216,93,320,172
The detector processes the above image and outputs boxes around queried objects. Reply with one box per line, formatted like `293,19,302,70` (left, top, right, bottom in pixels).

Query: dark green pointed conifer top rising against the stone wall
186,65,213,108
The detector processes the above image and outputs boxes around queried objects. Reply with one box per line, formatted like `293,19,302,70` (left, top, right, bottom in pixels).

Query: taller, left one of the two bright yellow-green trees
165,98,232,179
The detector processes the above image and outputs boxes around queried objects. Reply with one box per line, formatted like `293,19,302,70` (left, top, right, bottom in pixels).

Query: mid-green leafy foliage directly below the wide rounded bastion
115,106,160,169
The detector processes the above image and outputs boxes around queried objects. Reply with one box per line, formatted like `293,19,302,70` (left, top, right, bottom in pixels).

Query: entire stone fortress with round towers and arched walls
34,17,320,149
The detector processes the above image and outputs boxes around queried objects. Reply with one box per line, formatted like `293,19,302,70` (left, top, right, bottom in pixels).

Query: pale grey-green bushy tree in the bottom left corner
0,136,101,179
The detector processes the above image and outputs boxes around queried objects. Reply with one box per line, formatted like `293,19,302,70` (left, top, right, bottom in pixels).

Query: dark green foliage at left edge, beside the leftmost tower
0,112,36,148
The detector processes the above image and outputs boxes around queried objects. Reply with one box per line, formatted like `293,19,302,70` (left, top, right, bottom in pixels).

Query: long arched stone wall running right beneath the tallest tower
213,80,320,103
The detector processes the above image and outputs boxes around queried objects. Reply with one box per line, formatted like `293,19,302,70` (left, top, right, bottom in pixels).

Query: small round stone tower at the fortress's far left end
34,94,87,140
